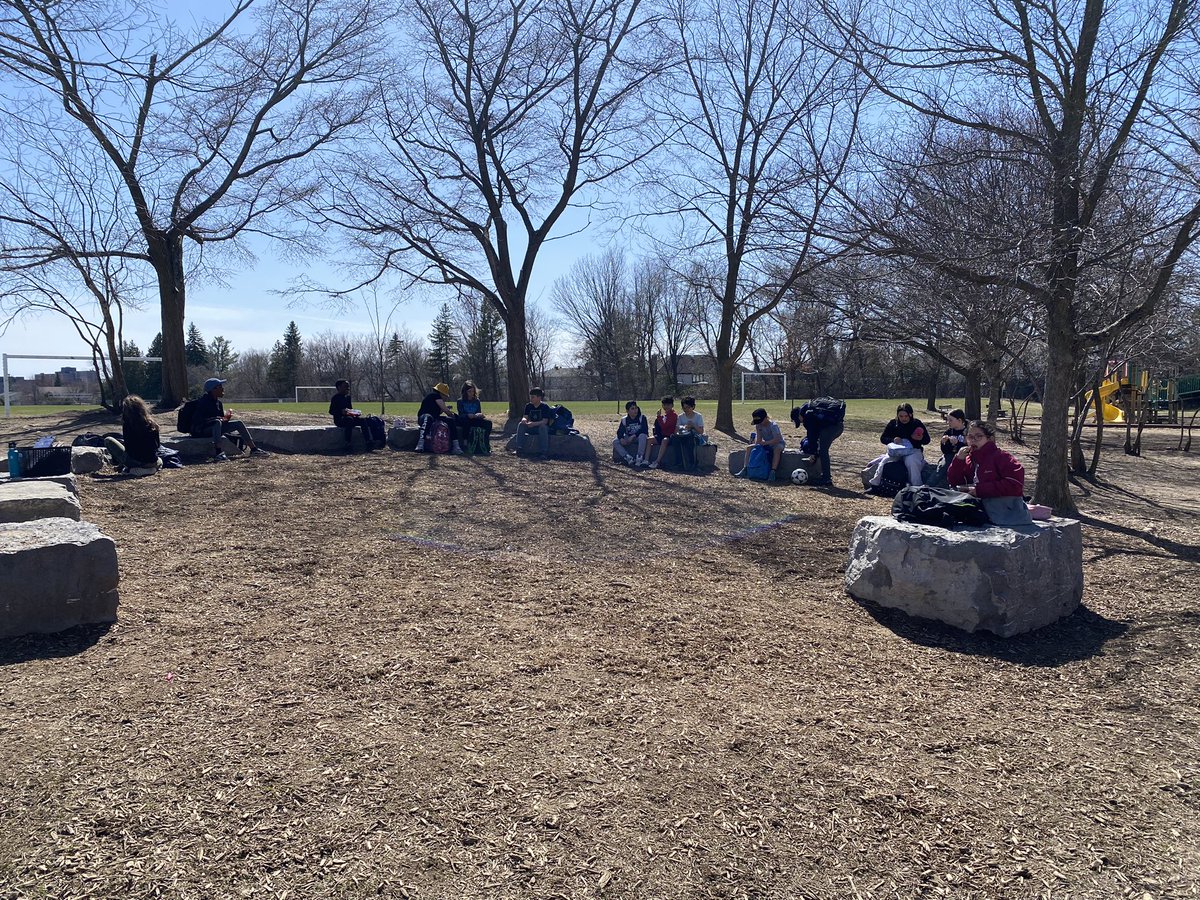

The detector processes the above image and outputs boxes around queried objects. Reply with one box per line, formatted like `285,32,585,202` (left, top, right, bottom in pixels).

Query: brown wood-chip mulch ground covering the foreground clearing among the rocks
0,414,1200,900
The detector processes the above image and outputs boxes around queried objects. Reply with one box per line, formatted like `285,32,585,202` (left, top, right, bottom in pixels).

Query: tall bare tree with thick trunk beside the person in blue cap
0,0,379,407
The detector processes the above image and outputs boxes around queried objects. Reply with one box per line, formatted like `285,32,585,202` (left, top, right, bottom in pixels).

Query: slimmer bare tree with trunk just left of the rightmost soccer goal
652,0,864,432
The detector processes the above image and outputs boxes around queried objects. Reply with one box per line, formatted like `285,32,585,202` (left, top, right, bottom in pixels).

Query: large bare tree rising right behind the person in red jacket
828,0,1200,512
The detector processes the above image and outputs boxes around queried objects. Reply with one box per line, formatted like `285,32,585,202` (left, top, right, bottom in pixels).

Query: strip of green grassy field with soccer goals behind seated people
2,397,1040,425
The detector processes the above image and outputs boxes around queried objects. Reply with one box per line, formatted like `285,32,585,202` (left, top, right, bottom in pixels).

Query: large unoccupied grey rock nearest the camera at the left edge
0,518,118,637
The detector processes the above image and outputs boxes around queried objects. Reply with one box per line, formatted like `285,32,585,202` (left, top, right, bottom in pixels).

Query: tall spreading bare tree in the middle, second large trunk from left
322,0,662,419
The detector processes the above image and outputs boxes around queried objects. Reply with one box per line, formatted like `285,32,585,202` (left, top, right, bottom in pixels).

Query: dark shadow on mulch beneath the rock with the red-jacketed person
847,595,1129,668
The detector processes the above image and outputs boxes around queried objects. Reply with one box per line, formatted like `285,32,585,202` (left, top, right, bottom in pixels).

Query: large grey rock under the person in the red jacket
846,516,1084,637
